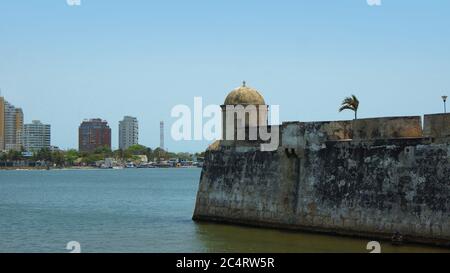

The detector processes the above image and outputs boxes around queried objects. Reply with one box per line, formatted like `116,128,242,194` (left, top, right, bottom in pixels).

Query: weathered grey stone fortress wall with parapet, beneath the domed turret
193,114,450,246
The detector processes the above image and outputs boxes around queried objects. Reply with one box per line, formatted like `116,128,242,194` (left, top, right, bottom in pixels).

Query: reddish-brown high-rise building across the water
78,119,111,152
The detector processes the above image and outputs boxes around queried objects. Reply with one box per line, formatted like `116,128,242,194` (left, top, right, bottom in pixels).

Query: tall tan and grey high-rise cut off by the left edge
0,97,23,151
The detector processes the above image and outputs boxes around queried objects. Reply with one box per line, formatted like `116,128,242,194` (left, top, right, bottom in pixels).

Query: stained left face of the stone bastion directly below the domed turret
194,149,296,225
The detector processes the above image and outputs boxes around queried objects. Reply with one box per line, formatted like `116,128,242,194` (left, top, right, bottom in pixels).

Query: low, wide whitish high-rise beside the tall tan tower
23,120,51,152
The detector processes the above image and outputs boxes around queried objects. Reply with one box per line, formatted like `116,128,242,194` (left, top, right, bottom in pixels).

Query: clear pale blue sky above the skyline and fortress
0,0,450,151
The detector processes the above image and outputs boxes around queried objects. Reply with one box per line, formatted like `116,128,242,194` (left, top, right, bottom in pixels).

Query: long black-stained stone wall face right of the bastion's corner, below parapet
297,139,450,246
